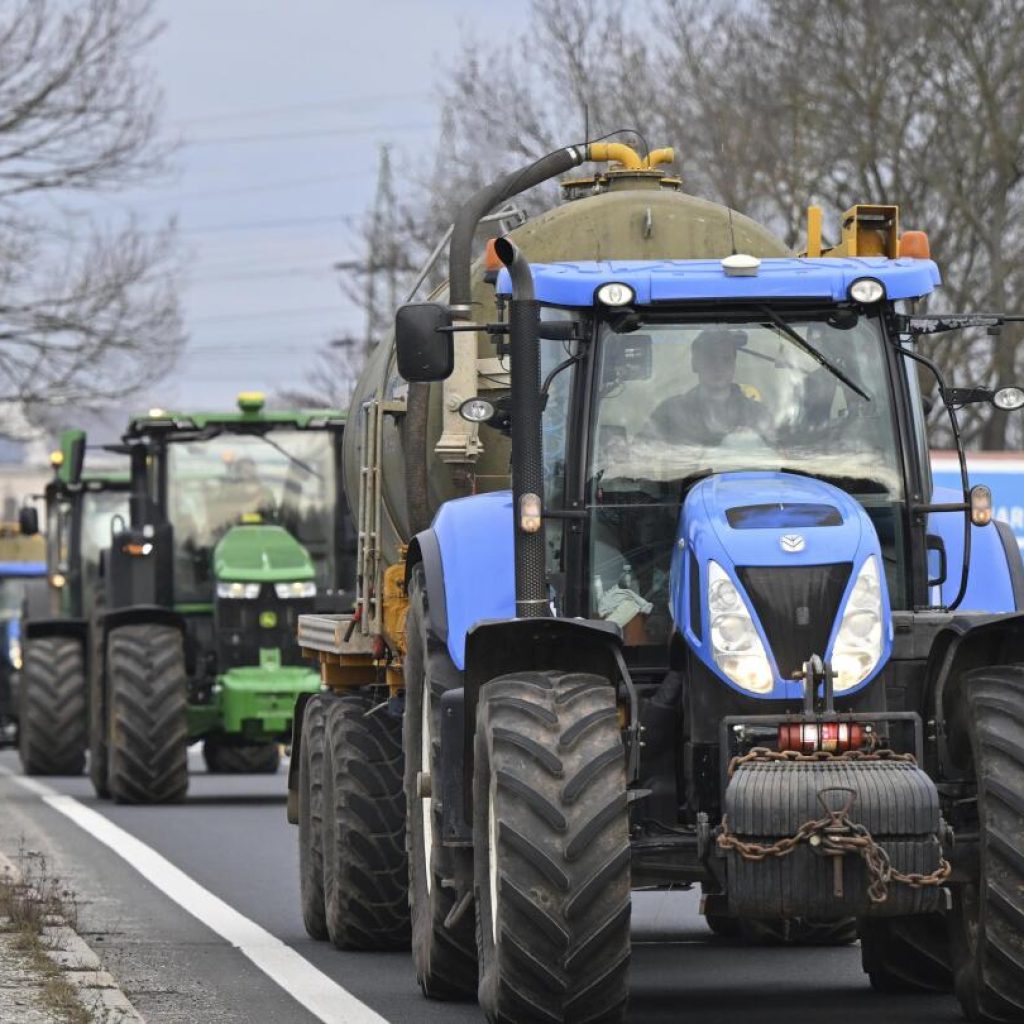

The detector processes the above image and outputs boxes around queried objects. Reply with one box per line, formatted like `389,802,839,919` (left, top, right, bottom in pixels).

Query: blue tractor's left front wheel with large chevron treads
473,672,630,1024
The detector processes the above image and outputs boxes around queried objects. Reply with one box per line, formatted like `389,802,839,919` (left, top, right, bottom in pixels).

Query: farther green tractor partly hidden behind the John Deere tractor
17,430,128,775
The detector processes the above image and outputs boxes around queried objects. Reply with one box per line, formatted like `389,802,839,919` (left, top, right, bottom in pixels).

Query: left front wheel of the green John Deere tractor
106,625,188,804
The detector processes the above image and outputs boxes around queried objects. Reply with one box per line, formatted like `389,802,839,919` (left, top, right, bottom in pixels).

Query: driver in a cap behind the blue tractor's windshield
650,328,769,444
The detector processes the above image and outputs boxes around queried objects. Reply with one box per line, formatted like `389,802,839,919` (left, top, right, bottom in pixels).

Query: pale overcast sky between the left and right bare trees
112,0,528,408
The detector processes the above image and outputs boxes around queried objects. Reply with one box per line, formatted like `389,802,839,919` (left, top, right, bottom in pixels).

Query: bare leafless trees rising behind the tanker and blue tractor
342,0,1024,449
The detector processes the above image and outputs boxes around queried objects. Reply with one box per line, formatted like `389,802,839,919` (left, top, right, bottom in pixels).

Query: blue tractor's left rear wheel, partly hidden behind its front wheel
404,565,477,999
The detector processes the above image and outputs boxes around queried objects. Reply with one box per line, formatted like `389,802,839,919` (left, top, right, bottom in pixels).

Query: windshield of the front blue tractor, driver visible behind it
588,313,905,643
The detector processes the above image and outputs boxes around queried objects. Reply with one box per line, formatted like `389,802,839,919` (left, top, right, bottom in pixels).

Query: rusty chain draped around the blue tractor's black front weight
717,746,952,903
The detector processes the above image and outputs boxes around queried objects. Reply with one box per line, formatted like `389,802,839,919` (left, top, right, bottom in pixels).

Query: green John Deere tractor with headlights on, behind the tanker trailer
90,392,355,804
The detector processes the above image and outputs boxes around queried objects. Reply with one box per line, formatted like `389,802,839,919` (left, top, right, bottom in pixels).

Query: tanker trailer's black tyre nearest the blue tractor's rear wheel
324,693,410,949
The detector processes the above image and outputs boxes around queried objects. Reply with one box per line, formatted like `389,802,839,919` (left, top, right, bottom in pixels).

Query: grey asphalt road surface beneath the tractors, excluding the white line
0,751,962,1024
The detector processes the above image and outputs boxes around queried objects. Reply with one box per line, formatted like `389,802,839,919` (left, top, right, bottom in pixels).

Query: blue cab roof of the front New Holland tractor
498,256,942,306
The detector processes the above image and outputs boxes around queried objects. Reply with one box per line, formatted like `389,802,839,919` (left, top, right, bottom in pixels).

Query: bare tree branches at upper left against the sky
0,0,182,412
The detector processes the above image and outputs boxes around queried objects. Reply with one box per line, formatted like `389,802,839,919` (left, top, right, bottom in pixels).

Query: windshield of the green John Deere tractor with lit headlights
167,429,336,602
